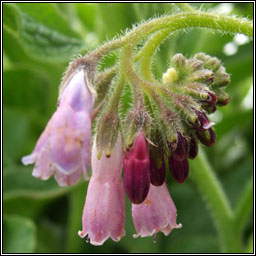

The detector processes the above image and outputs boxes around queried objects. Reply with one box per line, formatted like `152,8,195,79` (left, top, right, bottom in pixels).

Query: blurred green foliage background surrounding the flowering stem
3,3,253,253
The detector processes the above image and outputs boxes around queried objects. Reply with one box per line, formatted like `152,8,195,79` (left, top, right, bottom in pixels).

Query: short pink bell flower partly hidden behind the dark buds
132,183,182,238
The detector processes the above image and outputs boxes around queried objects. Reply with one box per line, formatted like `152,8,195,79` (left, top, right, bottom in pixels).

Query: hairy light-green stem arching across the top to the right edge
87,11,253,59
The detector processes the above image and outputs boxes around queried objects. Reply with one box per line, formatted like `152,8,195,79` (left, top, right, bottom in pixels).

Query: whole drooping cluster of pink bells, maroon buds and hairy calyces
22,50,230,245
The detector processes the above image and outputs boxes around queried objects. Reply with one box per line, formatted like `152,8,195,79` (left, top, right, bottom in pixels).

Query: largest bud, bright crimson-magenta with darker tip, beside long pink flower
124,132,150,204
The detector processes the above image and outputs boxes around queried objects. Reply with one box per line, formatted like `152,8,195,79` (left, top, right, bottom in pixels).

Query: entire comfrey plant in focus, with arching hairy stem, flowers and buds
22,4,253,250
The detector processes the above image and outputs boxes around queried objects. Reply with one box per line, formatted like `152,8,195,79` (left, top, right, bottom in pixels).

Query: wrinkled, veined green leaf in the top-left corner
5,3,84,62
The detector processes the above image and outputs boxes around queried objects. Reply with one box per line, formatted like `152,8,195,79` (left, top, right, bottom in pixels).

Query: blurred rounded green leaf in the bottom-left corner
3,216,36,253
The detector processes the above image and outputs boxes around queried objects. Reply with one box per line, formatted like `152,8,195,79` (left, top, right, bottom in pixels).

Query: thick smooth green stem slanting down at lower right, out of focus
190,148,242,253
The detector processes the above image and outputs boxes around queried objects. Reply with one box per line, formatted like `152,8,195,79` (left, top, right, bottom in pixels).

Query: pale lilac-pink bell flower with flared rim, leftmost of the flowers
22,70,94,186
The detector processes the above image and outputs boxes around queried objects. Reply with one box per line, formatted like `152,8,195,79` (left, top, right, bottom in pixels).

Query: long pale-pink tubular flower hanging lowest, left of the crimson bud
78,137,125,245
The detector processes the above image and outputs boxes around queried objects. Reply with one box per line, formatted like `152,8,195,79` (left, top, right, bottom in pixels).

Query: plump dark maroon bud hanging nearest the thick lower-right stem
169,156,189,183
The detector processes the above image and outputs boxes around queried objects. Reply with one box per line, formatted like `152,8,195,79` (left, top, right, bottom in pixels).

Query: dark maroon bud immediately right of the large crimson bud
150,156,166,186
